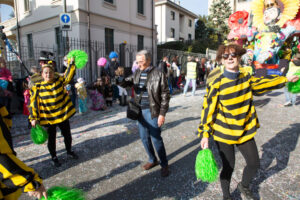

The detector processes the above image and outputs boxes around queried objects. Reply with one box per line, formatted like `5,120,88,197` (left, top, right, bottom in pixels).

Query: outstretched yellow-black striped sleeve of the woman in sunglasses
250,75,287,95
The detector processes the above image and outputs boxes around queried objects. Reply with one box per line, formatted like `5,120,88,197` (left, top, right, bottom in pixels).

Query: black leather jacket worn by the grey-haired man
121,66,170,118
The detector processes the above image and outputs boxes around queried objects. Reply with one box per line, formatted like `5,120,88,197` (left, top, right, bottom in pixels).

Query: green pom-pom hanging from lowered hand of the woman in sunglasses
195,149,219,183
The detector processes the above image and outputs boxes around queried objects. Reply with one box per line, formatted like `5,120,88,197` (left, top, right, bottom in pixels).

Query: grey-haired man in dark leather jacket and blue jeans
122,50,170,177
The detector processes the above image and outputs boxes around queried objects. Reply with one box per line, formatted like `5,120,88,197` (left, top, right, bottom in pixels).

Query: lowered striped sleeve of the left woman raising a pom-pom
29,85,39,121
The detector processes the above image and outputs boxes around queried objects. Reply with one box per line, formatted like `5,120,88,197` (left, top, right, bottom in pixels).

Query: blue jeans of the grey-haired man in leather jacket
138,109,168,167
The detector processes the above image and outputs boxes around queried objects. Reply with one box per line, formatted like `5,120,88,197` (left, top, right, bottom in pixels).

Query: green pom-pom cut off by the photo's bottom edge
40,186,85,200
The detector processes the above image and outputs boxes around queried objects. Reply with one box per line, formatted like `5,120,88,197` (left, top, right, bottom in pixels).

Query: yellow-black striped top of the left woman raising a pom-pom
29,65,76,125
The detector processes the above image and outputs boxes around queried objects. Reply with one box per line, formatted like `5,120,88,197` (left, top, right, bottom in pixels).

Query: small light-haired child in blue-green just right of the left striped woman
75,78,88,114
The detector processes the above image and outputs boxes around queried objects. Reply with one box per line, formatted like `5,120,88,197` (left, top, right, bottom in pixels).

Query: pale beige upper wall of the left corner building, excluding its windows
7,0,156,47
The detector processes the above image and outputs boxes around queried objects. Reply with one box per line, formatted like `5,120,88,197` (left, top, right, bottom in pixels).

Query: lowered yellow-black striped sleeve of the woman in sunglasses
198,80,219,138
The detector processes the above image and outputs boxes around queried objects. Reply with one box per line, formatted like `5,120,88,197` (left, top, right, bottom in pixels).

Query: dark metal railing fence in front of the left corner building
6,38,152,83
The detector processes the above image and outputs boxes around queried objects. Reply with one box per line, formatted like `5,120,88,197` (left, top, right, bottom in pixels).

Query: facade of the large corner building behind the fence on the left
0,0,156,79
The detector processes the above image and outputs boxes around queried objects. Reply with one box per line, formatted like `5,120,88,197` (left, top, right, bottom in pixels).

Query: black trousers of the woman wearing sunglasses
216,139,259,197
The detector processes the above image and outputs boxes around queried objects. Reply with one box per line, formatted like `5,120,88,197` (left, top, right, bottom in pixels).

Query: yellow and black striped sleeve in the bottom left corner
0,154,42,192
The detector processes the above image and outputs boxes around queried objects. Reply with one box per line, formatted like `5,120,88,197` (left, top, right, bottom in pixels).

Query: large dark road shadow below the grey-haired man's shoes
96,139,212,200
